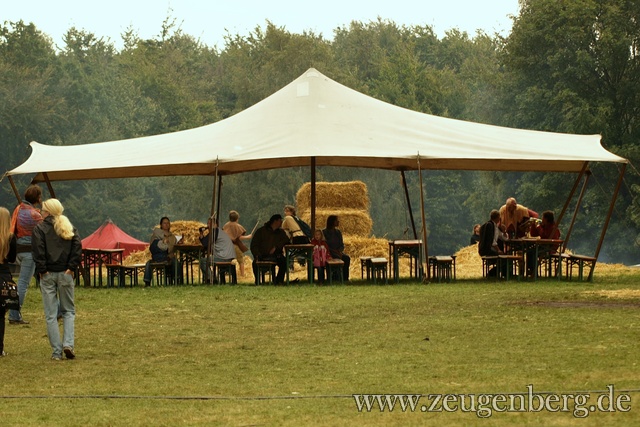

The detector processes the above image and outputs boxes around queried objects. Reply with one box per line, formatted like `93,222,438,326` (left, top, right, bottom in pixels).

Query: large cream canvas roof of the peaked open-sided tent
2,68,626,182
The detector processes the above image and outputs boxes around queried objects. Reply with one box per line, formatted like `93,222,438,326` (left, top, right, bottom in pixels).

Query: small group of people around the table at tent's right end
469,197,561,276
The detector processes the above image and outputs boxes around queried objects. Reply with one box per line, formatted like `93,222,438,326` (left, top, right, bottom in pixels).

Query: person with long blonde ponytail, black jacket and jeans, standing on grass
31,199,82,360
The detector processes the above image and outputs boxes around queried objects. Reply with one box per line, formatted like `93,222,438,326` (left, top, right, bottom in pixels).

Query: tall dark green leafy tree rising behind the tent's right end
502,0,640,261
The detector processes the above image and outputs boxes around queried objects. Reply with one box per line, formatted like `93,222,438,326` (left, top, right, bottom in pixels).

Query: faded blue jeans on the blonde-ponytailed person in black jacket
40,271,76,357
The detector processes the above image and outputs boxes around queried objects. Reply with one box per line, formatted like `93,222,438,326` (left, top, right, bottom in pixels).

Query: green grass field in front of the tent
0,274,640,426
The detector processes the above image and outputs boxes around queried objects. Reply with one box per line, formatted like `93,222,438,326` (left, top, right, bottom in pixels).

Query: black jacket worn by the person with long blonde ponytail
31,216,82,274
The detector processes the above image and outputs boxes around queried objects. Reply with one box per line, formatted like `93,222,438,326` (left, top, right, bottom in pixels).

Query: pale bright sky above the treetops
0,0,518,48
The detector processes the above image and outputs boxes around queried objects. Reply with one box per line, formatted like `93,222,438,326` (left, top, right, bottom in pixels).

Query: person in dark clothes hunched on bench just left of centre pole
251,214,289,285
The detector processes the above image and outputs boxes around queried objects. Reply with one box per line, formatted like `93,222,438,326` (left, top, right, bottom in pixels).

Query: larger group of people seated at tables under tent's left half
144,205,351,286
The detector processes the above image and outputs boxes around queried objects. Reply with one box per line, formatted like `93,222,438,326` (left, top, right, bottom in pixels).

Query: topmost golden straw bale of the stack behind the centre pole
296,181,369,214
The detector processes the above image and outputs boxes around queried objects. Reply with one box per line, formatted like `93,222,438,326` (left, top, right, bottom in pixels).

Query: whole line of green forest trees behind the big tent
0,0,640,264
